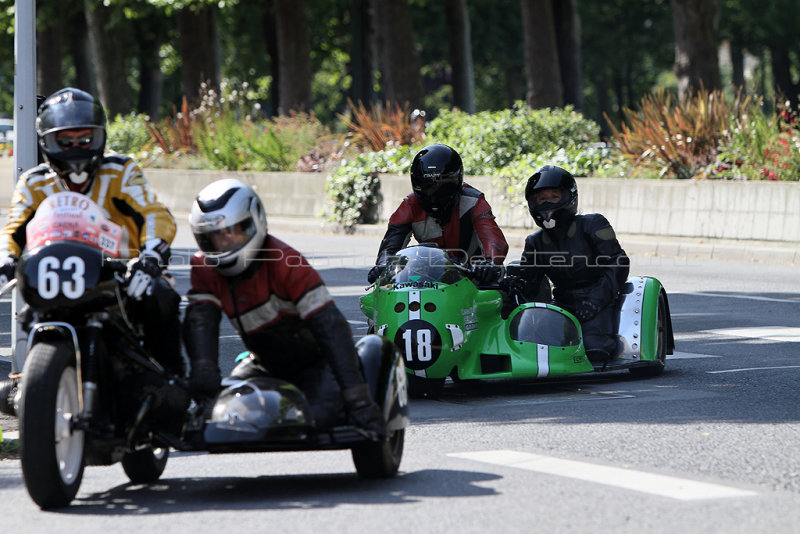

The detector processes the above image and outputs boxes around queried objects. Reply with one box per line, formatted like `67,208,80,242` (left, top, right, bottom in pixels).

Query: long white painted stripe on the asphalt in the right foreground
448,450,757,501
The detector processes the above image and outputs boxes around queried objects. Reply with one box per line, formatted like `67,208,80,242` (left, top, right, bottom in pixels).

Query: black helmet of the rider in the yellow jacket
36,87,106,193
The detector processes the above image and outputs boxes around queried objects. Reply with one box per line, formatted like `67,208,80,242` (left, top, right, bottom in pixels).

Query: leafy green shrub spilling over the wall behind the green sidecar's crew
326,102,630,229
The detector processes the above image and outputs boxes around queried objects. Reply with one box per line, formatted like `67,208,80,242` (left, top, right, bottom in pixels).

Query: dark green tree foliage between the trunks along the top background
0,0,800,134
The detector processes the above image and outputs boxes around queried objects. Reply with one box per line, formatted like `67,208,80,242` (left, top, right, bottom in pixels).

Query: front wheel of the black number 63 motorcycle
19,340,84,508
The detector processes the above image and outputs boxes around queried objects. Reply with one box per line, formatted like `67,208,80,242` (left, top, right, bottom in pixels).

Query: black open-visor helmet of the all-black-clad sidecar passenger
525,165,578,230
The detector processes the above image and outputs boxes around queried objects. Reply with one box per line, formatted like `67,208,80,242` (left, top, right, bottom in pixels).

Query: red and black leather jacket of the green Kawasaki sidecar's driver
376,184,508,265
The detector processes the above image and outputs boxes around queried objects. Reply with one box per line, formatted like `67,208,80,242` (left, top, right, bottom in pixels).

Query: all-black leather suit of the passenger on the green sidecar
520,213,630,359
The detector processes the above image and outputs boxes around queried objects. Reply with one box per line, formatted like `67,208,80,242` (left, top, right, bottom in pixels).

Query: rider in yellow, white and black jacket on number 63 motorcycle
0,87,183,411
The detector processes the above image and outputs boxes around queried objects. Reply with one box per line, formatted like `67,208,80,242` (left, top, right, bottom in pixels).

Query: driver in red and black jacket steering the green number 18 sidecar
367,144,508,283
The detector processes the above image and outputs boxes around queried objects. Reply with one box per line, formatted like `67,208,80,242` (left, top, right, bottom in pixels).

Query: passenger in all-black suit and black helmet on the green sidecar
518,165,630,362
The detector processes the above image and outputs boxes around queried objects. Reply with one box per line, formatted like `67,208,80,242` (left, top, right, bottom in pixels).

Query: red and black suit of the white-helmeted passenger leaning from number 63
184,235,364,426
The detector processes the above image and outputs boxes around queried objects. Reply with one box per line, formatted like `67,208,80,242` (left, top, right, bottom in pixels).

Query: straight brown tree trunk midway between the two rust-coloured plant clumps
275,0,311,115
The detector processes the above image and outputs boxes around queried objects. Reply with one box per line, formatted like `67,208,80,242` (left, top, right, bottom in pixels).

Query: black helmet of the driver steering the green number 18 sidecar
411,145,464,222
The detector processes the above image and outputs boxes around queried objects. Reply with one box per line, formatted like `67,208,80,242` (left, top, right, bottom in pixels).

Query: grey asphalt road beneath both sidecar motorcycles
0,229,800,533
